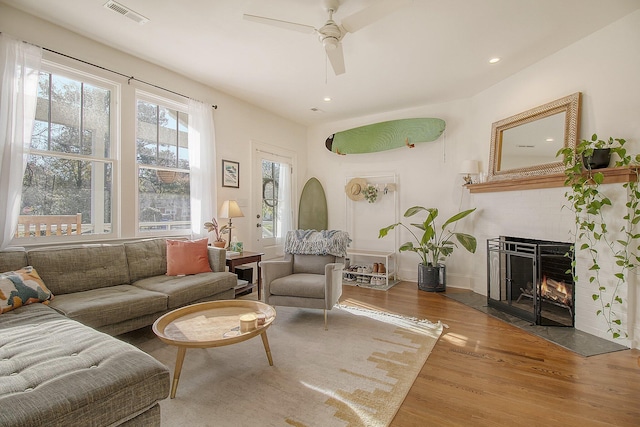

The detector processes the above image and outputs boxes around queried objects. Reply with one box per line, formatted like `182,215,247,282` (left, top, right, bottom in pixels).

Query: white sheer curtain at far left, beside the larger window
0,33,42,249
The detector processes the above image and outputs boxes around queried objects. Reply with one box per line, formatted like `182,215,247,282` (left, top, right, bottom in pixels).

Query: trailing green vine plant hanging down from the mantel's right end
557,134,640,338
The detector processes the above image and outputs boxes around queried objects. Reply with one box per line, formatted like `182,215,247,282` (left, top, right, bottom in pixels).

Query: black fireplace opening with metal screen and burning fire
487,236,575,327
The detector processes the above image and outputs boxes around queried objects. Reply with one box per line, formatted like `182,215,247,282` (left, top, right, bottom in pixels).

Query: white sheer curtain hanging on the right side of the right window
189,99,218,238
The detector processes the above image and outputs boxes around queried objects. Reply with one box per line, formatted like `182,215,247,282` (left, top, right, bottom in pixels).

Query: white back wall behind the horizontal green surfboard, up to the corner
308,100,475,287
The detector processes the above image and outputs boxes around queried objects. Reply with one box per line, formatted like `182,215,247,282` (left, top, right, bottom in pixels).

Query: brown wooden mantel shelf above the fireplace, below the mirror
465,166,640,193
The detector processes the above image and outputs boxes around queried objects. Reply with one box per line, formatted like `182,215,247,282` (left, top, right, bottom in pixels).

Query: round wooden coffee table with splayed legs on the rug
153,300,276,399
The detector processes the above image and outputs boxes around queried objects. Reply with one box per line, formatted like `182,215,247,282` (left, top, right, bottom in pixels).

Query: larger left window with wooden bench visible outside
17,64,118,238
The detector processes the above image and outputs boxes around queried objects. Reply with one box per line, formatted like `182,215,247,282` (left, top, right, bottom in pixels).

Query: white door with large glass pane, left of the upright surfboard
251,144,295,259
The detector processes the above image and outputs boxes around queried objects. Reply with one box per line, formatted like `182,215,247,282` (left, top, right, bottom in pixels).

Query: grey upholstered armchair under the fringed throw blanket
260,232,349,329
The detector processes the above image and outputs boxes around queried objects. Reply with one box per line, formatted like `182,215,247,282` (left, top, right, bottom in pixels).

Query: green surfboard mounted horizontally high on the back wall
325,118,445,154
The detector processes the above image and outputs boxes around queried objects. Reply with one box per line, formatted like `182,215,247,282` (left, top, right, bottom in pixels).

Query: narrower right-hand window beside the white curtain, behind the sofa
136,94,191,234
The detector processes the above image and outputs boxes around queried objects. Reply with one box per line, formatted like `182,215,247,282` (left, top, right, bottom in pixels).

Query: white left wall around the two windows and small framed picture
0,4,307,249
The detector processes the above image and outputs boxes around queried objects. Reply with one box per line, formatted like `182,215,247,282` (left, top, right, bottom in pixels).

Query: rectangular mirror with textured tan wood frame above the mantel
488,92,581,181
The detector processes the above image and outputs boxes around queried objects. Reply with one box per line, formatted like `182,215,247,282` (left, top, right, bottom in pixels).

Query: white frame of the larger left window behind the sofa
12,60,122,246
